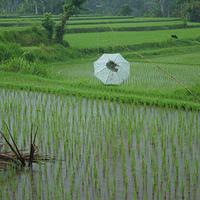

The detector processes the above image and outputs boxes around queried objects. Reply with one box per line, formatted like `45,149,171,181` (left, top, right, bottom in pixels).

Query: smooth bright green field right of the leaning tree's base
64,28,200,48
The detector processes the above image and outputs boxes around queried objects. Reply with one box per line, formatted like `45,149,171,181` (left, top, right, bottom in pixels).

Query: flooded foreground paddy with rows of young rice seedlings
0,89,200,199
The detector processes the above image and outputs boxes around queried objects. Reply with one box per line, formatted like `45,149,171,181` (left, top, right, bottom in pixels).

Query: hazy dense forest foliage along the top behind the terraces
0,0,200,21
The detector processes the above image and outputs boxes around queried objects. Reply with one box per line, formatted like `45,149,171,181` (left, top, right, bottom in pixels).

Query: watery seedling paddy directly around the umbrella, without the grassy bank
48,61,199,93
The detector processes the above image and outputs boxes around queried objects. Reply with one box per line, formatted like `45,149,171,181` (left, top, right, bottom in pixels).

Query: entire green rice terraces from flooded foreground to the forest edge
0,15,200,200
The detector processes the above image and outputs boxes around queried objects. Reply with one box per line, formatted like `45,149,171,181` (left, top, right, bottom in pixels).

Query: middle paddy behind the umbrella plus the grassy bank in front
0,57,200,109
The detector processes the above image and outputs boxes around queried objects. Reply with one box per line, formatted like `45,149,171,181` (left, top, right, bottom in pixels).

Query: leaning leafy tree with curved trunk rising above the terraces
55,0,86,43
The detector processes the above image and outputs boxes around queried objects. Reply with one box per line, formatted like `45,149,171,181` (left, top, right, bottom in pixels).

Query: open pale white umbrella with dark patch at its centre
94,53,130,85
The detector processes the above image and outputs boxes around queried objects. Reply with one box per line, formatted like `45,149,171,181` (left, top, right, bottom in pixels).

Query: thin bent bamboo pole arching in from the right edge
101,39,200,103
